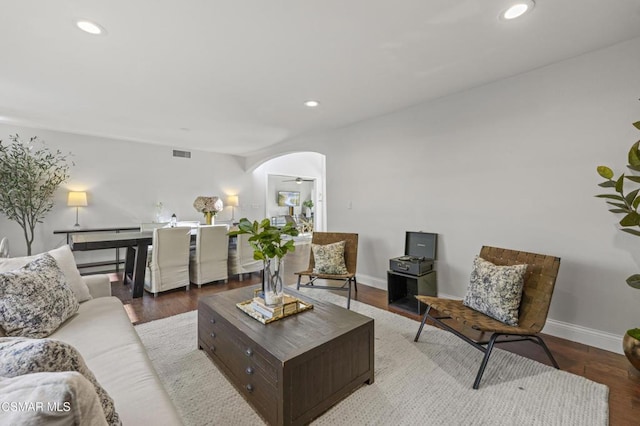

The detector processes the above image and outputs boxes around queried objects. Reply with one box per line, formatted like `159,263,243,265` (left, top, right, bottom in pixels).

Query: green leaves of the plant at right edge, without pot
596,121,640,289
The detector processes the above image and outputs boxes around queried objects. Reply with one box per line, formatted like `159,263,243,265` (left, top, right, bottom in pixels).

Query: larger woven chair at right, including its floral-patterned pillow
414,246,560,389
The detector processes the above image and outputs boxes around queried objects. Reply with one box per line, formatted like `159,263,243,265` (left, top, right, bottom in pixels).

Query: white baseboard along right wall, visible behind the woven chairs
358,274,624,354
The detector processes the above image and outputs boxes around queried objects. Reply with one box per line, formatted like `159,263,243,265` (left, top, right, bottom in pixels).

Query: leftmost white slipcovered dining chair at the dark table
144,227,191,295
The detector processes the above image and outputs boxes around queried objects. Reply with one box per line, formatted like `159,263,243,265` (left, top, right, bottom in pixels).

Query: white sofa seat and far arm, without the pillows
0,250,182,425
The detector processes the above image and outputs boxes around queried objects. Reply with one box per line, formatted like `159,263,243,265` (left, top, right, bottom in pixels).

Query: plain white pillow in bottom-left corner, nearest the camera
0,371,107,426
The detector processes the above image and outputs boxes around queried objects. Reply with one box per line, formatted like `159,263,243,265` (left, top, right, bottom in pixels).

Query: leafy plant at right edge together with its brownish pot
596,114,640,370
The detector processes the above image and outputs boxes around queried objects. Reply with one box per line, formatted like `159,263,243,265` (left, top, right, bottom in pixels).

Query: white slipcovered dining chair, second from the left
189,225,229,287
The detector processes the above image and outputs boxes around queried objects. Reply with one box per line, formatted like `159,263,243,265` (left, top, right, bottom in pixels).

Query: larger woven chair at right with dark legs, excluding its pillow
414,246,560,389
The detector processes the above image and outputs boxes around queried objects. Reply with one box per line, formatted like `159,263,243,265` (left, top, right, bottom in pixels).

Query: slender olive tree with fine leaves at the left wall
0,135,70,255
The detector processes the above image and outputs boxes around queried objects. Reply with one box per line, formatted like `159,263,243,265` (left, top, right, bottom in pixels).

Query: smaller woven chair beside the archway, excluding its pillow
295,232,358,309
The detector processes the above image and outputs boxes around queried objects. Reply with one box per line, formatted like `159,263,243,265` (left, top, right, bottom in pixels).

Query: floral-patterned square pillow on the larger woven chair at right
462,256,527,326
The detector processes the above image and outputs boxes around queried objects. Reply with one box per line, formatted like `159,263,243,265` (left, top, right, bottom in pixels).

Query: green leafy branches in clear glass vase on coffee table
229,218,298,306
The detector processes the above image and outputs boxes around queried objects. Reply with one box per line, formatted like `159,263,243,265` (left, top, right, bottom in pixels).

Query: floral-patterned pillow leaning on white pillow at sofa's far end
0,253,79,337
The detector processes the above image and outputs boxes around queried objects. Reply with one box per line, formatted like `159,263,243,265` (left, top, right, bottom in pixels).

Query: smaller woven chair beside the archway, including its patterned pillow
295,232,358,309
